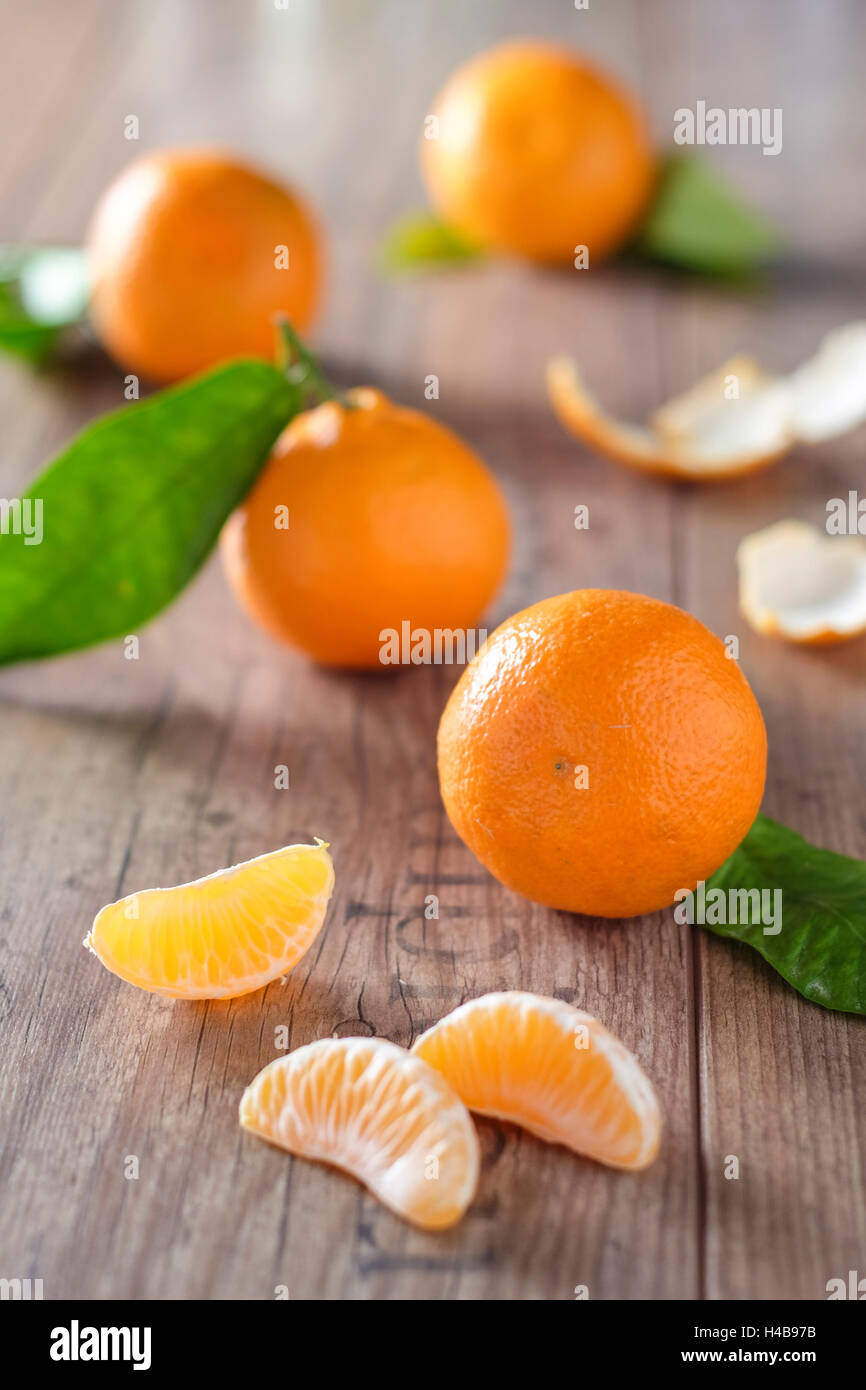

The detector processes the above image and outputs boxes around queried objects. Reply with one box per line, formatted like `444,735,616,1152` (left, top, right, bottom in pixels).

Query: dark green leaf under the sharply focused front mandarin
705,816,866,1013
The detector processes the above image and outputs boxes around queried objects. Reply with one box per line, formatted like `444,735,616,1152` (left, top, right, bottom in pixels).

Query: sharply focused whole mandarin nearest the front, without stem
439,589,767,917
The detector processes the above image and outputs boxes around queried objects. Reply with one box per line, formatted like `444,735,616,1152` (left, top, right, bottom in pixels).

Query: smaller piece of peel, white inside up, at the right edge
737,521,866,644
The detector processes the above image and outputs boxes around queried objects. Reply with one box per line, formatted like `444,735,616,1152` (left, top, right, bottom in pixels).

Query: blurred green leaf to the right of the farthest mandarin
632,156,781,275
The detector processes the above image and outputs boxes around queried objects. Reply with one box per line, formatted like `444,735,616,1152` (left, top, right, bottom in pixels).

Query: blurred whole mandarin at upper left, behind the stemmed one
88,149,321,381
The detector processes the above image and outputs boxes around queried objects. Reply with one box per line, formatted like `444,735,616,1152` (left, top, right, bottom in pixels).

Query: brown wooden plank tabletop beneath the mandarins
0,0,866,1300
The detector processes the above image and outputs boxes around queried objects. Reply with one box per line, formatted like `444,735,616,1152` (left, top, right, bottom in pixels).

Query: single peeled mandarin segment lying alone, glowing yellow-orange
85,840,334,999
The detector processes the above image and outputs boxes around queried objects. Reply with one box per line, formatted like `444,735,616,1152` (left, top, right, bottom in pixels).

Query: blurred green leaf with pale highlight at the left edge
0,246,89,363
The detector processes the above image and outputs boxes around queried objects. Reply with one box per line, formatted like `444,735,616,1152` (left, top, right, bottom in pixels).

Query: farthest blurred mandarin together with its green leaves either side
382,38,780,277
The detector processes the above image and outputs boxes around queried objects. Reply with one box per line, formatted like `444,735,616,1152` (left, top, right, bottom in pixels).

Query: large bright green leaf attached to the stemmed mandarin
0,360,299,663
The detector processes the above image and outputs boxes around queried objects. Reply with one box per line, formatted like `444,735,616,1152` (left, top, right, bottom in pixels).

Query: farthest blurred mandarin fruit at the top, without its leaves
421,39,655,265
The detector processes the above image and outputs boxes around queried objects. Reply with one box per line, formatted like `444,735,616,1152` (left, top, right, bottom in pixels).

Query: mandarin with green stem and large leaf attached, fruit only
221,388,510,667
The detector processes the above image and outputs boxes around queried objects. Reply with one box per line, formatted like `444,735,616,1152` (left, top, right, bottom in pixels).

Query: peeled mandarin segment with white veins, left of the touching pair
240,1038,480,1230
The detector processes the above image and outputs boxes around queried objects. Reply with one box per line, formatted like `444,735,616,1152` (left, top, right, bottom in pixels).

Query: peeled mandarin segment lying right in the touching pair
411,990,662,1169
